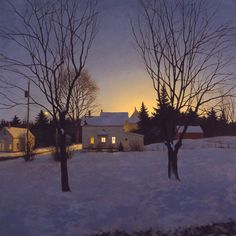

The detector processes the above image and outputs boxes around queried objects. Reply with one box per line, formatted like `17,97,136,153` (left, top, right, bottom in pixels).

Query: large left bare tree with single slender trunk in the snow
1,0,97,192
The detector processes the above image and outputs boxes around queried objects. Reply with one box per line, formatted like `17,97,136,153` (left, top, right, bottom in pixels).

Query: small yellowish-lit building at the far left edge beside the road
0,127,35,152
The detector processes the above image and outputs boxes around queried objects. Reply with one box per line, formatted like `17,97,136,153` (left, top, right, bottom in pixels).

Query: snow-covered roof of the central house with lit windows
82,112,128,126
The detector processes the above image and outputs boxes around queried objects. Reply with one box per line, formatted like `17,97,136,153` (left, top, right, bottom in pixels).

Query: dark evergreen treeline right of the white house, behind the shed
137,102,236,144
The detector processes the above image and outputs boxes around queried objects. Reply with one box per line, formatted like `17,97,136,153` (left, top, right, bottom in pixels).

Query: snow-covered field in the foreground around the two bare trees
0,138,236,236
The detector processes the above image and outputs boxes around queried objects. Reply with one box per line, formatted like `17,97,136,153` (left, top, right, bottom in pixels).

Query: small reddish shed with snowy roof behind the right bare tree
177,126,204,139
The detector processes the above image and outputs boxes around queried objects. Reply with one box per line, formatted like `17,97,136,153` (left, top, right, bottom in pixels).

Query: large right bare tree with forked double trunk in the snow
131,0,233,180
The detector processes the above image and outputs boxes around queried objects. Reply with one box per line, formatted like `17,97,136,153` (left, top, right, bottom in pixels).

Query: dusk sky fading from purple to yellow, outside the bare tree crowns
0,0,236,120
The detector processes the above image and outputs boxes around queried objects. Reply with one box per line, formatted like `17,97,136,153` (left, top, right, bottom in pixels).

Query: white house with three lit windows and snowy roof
82,111,144,151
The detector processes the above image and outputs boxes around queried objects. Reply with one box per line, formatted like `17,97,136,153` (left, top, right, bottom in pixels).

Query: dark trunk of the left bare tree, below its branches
58,112,71,192
